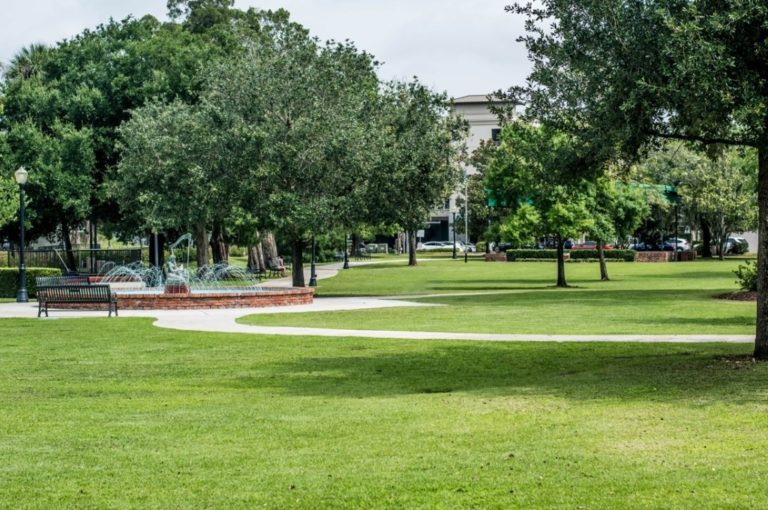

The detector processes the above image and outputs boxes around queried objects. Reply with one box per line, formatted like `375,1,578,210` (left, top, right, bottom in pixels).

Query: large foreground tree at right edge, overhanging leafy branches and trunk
508,0,768,358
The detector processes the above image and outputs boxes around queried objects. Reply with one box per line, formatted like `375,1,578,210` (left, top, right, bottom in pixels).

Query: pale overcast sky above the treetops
0,0,530,97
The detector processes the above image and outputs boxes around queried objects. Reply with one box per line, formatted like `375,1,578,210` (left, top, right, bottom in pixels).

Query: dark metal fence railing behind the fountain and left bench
5,248,141,275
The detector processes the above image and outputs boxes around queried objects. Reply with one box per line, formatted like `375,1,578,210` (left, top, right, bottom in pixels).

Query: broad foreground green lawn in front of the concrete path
0,318,768,509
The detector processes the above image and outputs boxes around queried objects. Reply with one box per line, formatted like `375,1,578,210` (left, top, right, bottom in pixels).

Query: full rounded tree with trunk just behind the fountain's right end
209,17,378,286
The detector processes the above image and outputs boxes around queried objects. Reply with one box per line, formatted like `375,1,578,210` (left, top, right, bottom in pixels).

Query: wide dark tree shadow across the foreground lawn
236,339,768,406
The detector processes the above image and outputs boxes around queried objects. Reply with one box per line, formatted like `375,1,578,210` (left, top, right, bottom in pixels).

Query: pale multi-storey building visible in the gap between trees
421,95,516,242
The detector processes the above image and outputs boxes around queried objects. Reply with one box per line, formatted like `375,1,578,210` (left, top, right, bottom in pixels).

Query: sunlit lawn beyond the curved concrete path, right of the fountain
241,260,755,334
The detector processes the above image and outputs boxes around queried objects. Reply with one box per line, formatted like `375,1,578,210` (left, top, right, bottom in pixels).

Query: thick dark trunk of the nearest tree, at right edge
754,140,768,359
